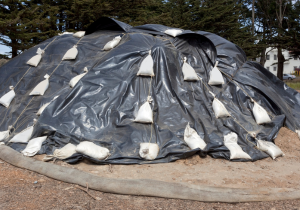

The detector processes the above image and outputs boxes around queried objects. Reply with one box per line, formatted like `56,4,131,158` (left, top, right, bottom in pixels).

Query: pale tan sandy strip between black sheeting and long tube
35,128,300,188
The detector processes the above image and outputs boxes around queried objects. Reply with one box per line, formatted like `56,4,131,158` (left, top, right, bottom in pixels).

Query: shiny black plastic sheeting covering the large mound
0,18,300,164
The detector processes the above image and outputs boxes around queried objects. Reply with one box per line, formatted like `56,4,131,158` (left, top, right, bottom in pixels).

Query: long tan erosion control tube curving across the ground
0,145,300,202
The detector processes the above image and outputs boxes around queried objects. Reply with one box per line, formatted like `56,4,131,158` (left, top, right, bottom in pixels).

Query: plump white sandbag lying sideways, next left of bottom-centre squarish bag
76,141,110,160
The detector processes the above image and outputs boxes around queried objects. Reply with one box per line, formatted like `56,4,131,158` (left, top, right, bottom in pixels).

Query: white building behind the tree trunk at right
265,47,300,76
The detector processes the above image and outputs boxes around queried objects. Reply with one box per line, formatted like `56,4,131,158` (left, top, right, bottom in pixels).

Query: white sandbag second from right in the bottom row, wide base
224,132,251,160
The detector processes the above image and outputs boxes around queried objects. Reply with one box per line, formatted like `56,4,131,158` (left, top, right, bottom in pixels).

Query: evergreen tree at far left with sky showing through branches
0,0,58,57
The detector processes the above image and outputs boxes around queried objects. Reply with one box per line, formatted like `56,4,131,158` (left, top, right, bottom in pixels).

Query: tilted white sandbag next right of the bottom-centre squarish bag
184,123,206,150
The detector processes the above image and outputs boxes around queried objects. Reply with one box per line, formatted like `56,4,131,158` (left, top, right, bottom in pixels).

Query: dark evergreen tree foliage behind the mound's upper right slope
166,0,258,58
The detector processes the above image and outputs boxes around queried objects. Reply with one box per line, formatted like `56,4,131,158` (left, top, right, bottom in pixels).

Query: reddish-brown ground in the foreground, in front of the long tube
0,157,300,210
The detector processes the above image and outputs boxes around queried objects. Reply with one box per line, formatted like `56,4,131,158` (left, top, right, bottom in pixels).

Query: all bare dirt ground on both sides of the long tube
0,128,300,210
